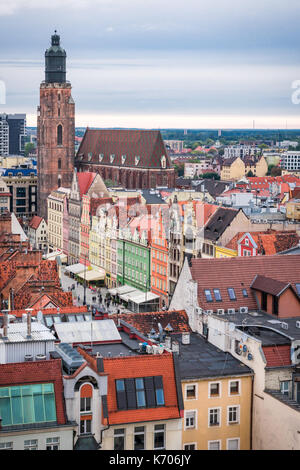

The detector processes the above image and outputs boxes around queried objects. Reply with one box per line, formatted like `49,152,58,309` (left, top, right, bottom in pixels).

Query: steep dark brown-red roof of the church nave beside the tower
77,129,172,169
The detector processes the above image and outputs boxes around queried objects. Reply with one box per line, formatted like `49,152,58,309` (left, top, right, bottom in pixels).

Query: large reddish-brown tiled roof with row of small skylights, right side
191,255,300,310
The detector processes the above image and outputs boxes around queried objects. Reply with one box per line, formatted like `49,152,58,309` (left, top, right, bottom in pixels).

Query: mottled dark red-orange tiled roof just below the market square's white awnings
110,310,191,335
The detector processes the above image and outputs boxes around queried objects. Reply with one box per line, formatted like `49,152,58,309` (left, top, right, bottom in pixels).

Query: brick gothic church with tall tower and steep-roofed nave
37,35,175,220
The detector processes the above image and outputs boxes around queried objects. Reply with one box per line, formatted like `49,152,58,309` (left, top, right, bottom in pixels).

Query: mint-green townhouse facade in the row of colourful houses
117,240,151,292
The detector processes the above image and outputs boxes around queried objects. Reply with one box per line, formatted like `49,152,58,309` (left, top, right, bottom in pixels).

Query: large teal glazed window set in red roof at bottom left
0,383,56,426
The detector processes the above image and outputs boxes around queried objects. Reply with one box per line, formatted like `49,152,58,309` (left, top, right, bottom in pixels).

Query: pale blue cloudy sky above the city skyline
0,0,300,128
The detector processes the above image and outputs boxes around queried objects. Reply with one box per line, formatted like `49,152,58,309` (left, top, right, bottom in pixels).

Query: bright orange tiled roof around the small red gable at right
226,230,300,255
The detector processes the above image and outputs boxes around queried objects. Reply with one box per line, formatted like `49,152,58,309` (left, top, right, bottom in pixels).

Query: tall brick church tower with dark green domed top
37,31,75,220
